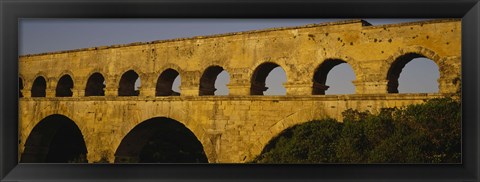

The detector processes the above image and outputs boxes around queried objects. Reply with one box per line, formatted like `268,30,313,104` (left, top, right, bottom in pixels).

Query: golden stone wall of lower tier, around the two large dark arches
19,94,442,163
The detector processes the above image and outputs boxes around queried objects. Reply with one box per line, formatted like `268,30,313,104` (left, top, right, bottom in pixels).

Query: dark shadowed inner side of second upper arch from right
312,59,356,95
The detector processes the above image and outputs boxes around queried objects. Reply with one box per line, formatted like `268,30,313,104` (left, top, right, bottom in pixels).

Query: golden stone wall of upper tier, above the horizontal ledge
20,20,461,97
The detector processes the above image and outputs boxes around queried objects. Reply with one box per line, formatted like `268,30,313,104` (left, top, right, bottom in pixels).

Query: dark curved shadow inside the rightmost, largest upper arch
387,53,438,93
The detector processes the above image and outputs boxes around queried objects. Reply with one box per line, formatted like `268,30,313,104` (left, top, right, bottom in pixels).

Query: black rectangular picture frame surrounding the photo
0,0,480,182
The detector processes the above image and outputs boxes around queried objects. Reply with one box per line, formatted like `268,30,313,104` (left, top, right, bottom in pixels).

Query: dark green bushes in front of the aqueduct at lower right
251,98,461,163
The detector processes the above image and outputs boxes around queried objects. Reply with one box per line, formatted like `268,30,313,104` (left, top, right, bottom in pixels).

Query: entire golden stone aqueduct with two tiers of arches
19,19,461,163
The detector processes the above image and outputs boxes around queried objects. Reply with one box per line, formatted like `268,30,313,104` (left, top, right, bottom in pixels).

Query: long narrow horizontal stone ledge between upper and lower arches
20,93,451,102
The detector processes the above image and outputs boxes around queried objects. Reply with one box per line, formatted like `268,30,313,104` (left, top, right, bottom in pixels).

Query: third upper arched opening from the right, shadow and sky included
250,62,287,95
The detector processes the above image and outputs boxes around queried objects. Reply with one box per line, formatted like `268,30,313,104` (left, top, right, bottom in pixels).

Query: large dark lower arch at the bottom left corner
20,114,87,163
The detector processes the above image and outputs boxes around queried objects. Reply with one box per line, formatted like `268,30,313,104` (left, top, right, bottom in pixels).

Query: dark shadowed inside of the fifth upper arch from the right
155,69,180,96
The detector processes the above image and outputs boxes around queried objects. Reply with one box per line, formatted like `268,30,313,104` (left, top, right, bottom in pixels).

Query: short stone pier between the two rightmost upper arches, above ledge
352,80,388,94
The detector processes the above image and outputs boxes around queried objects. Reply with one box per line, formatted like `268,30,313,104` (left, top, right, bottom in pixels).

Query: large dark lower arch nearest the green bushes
115,117,208,163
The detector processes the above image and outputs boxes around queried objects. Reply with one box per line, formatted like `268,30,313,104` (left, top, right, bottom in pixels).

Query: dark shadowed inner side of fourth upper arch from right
199,66,229,95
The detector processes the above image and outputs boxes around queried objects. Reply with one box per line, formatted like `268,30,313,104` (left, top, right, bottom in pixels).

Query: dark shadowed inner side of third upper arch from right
250,62,280,95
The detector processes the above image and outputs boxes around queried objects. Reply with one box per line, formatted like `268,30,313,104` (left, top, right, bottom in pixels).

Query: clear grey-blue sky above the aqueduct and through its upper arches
19,19,439,95
